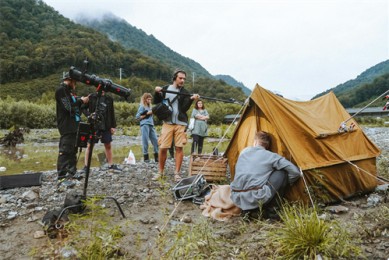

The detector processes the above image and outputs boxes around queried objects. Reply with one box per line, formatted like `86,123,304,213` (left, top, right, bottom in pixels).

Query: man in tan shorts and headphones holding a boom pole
153,70,200,182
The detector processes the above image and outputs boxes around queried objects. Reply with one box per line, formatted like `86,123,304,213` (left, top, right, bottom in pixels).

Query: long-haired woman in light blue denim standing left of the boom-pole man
136,93,159,162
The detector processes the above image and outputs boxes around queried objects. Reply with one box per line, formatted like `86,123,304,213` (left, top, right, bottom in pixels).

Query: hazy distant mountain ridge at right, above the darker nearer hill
312,60,389,99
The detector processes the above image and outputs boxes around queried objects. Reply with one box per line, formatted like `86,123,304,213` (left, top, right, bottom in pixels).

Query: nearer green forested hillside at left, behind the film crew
0,0,245,102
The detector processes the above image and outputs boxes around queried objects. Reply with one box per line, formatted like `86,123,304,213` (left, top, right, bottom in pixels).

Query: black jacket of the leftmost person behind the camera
55,82,83,135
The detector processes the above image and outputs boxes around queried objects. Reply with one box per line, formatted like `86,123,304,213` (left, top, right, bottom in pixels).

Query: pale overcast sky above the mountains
44,0,389,100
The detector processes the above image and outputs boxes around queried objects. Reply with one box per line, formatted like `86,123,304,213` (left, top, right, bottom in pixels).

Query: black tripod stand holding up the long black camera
55,87,126,227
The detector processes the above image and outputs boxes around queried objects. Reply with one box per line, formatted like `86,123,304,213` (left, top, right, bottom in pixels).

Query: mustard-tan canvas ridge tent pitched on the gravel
225,85,380,202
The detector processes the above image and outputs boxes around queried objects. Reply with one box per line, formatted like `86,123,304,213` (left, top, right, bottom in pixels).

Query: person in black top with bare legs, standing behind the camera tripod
82,91,121,172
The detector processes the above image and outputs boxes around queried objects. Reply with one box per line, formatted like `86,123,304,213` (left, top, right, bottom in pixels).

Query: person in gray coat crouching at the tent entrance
231,131,300,218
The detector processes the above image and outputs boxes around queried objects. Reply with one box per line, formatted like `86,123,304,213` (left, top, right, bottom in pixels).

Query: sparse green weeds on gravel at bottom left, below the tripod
31,198,125,259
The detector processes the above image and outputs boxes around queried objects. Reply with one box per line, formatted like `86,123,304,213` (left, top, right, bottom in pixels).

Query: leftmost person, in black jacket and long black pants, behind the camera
55,73,89,185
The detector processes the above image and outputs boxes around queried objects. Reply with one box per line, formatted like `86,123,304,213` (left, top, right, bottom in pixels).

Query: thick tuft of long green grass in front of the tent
268,204,362,259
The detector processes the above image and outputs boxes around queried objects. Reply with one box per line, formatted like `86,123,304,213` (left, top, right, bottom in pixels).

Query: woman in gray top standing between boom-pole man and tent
191,100,209,154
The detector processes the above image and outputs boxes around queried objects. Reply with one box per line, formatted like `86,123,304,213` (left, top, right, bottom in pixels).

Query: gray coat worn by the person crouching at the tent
231,146,300,210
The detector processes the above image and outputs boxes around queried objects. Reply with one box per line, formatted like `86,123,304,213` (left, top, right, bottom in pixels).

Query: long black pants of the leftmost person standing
57,133,77,178
